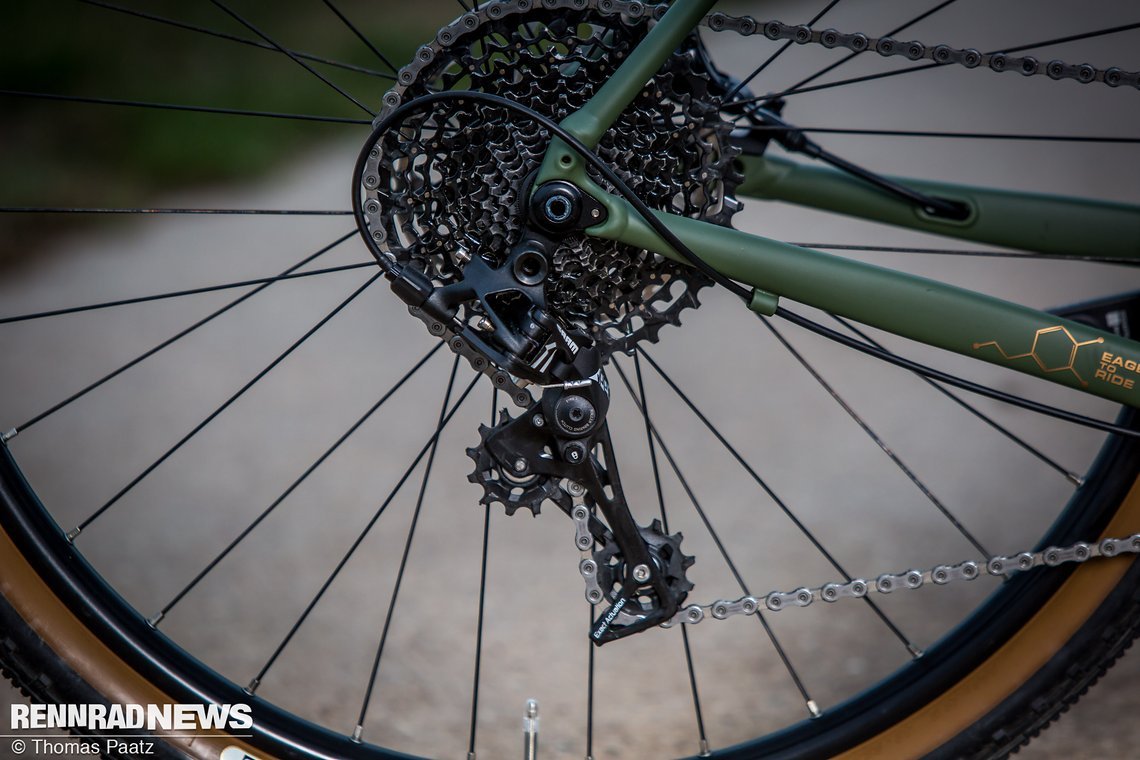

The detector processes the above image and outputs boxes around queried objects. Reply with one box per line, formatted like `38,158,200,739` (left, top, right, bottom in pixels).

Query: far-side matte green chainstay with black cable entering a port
736,156,1140,259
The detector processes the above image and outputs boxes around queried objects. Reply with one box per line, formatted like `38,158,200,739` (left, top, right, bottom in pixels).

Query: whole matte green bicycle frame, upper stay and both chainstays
536,0,1140,407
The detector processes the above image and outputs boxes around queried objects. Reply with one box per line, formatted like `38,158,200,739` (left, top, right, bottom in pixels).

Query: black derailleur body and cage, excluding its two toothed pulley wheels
389,180,684,645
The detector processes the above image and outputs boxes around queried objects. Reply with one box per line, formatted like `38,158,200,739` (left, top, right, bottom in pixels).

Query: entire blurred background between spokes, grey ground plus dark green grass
0,0,1140,758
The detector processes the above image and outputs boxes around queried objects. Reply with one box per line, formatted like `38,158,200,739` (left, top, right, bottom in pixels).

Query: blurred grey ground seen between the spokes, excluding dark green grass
0,2,1140,759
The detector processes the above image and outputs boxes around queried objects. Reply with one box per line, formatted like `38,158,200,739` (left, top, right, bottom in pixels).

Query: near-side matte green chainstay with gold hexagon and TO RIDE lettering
584,186,1140,407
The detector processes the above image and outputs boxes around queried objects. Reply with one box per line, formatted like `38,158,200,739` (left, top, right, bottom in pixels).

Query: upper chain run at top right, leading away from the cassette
705,13,1140,88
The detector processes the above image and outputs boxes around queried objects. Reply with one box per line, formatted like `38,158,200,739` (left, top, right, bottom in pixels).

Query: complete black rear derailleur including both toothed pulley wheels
389,182,692,645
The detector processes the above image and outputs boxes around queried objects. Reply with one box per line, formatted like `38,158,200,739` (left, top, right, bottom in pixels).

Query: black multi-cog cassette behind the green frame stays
364,0,741,356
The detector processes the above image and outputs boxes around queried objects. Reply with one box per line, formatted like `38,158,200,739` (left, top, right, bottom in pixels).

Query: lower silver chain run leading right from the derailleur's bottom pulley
662,533,1140,628
